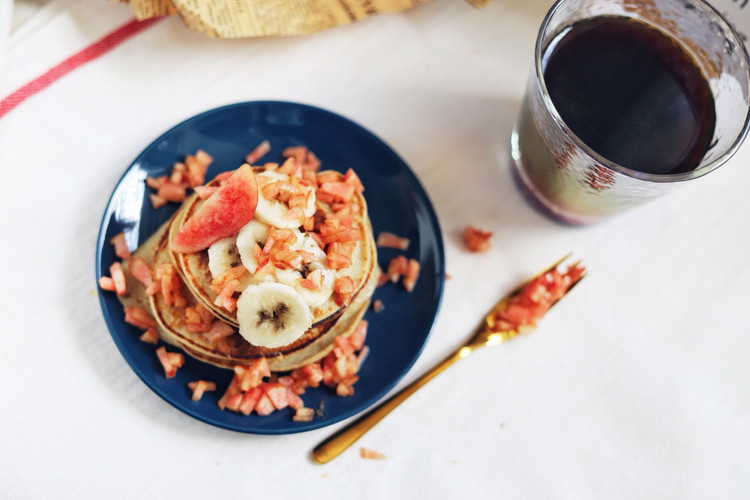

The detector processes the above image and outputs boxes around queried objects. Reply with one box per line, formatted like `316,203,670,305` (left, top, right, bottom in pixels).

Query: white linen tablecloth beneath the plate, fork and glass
0,0,750,499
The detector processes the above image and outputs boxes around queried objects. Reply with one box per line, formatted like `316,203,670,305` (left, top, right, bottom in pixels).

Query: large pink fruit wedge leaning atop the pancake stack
170,165,258,253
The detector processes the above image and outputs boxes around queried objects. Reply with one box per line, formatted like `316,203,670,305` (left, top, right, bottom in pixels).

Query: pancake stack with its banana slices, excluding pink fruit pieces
121,167,380,371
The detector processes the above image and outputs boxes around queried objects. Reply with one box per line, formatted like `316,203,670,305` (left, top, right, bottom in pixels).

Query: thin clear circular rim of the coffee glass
534,0,750,183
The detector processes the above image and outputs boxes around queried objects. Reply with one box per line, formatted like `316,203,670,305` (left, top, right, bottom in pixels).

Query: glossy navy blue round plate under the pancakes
96,101,445,434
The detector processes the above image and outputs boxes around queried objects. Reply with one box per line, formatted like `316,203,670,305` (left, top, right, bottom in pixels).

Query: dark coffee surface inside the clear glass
544,17,716,174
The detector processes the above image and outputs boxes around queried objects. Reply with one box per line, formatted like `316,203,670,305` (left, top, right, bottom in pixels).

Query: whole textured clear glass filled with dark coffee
511,0,750,224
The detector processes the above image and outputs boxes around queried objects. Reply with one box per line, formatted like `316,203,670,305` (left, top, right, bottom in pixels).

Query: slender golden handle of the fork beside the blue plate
312,347,471,464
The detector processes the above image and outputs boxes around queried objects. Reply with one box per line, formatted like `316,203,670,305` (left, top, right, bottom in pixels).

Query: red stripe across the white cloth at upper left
0,17,163,118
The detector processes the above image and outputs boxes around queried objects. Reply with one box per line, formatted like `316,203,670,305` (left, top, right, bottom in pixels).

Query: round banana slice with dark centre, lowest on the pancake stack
237,283,312,348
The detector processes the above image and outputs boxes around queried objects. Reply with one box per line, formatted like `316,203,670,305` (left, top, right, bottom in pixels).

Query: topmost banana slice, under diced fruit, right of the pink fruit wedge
255,170,316,229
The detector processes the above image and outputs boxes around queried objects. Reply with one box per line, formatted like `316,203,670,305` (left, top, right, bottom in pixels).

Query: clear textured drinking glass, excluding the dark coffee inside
511,0,750,225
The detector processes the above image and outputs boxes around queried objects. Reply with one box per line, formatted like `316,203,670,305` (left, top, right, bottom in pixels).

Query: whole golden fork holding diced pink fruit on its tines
312,254,585,464
